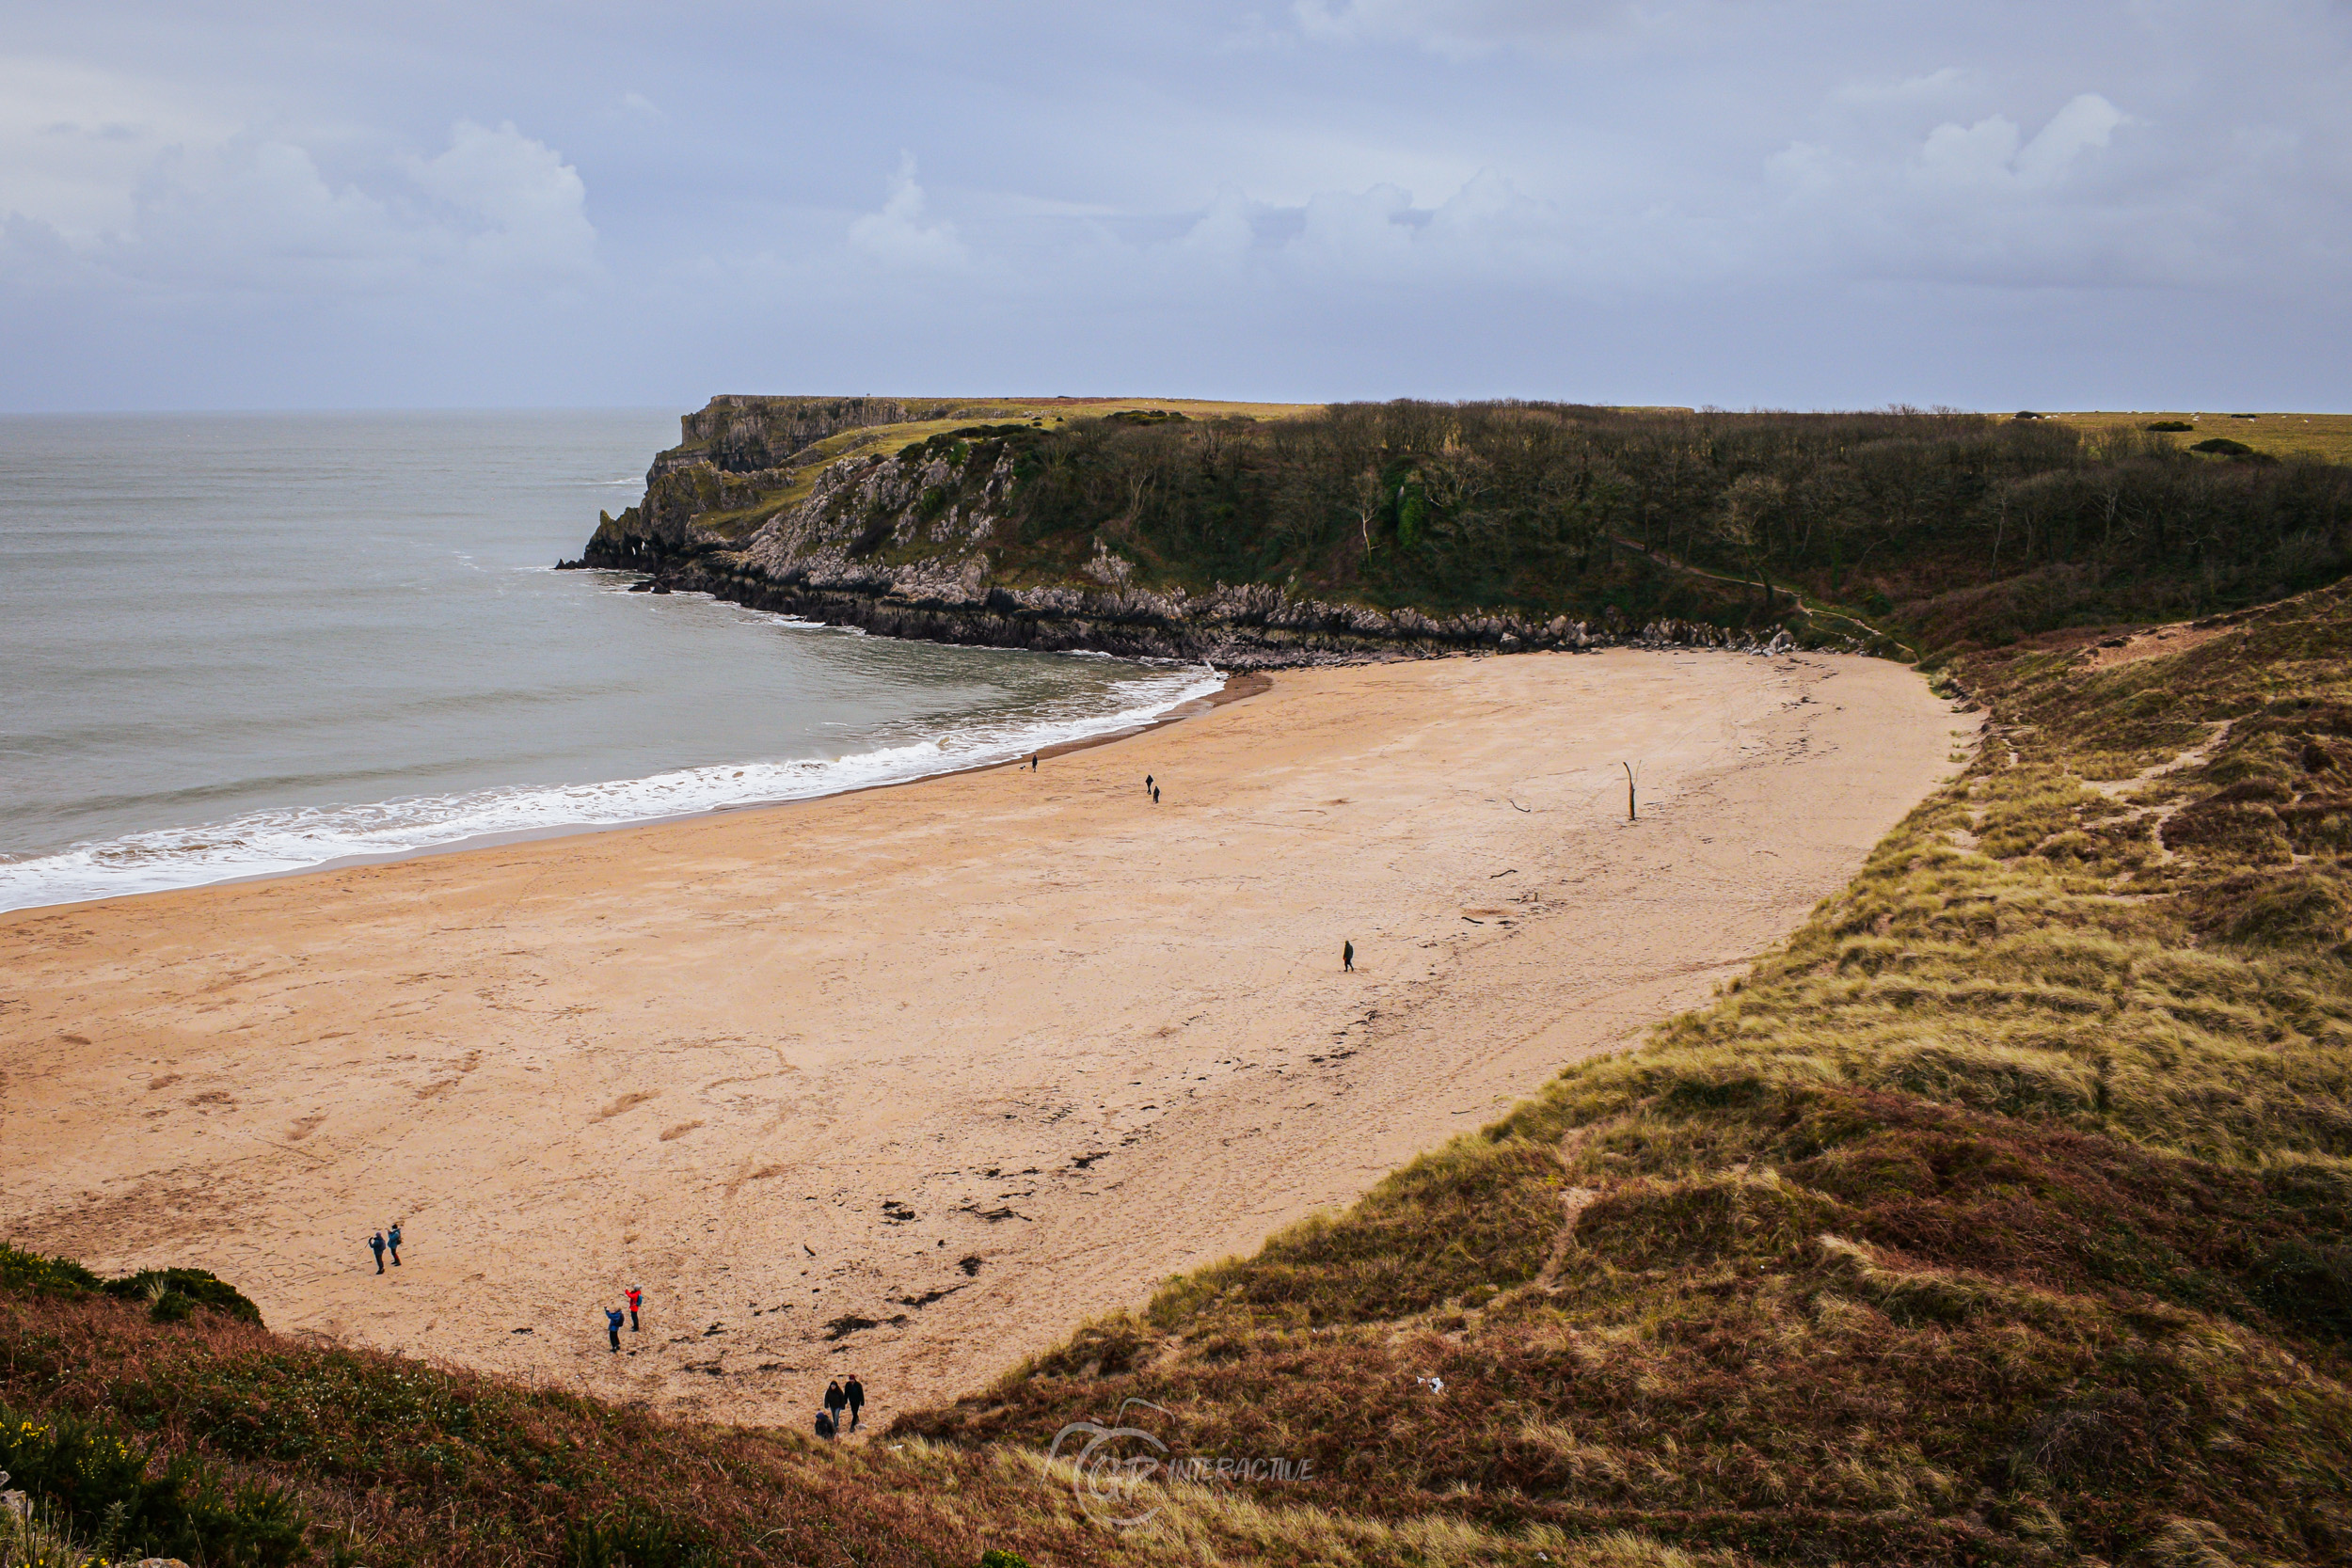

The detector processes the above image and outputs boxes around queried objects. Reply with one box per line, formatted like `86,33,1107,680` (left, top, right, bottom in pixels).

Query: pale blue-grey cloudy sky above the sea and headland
0,0,2352,411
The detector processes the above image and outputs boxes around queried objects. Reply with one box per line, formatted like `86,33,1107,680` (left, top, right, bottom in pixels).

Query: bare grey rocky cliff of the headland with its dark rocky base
577,397,1816,670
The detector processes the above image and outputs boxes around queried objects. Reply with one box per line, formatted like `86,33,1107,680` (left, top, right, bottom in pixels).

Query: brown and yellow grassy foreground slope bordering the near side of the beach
13,588,2352,1568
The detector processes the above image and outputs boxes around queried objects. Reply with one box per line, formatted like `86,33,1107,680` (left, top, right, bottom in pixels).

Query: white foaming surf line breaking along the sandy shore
0,667,1226,910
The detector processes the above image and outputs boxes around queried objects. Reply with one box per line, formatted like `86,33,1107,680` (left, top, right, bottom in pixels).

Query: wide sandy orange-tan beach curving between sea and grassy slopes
0,651,1974,1425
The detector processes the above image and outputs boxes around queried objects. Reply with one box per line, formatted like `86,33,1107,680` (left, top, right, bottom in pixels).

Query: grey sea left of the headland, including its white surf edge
0,411,1216,910
